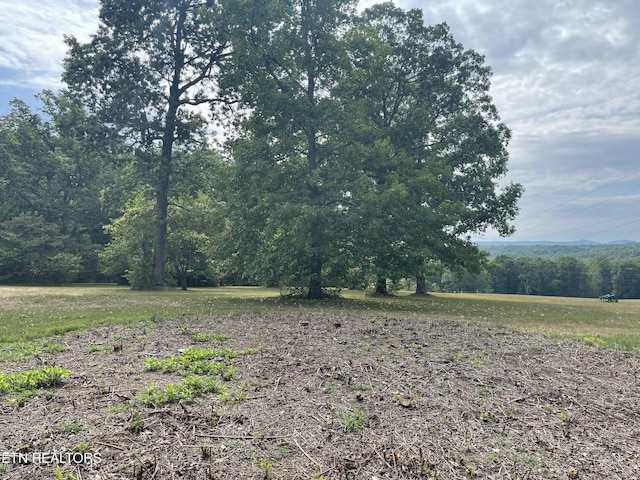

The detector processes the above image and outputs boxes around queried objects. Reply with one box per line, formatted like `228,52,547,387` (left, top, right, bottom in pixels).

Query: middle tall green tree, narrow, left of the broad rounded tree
231,0,360,298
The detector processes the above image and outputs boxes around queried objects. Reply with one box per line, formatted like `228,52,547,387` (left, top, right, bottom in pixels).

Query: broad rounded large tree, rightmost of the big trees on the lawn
336,3,522,293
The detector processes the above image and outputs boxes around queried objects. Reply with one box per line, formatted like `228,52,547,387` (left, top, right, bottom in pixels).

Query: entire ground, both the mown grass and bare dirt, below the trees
0,285,640,480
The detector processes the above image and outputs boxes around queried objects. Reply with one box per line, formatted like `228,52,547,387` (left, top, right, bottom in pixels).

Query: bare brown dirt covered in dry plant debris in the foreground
0,314,640,480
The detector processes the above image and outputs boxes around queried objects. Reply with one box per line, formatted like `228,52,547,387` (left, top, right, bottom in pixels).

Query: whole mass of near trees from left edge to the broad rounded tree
0,0,522,298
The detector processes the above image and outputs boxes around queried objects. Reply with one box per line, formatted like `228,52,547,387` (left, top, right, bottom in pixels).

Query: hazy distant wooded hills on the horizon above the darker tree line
478,240,640,262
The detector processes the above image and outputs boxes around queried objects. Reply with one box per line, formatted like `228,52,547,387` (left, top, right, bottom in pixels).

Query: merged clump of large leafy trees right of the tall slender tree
228,0,521,297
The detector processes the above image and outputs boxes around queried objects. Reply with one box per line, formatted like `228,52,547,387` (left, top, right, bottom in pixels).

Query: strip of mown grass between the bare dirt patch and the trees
0,285,640,351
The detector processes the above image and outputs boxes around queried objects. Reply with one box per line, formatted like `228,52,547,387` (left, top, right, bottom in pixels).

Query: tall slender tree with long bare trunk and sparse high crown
63,0,236,288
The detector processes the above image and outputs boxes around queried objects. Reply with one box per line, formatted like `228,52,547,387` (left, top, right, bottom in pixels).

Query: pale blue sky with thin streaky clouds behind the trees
0,0,640,243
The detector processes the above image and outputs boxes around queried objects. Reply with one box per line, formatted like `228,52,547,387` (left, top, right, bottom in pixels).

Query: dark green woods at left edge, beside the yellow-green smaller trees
0,97,112,283
